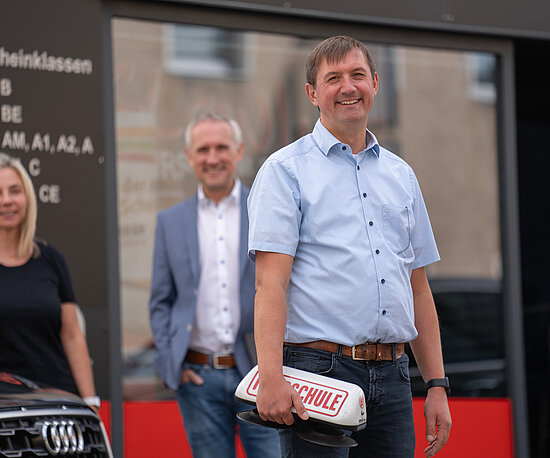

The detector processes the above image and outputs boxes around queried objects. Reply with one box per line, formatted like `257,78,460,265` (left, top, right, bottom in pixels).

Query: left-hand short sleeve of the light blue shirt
248,159,302,261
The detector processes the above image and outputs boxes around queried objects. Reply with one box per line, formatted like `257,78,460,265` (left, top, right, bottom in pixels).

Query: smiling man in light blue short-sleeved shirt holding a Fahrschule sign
248,37,451,458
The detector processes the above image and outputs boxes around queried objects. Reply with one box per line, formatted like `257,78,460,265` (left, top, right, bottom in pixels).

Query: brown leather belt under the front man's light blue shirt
285,340,405,361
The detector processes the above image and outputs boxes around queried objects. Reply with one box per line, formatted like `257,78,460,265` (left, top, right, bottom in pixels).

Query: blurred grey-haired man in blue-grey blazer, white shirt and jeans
149,113,280,458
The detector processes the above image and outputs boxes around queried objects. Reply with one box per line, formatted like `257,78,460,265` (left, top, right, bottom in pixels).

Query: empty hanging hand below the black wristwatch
424,387,452,457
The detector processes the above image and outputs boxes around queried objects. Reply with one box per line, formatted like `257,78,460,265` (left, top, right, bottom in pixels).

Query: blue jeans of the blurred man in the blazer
176,363,281,458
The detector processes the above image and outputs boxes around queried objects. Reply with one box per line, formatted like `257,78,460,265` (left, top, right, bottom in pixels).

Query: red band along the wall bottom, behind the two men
101,398,514,458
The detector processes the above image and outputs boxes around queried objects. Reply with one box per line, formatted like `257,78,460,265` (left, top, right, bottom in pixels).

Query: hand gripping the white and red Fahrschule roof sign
256,377,309,425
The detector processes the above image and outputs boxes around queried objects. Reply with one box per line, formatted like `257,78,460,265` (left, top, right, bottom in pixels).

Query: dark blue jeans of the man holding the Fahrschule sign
279,346,415,458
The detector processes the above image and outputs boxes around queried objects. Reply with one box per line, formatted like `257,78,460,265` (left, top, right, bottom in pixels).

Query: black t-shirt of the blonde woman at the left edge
0,243,78,394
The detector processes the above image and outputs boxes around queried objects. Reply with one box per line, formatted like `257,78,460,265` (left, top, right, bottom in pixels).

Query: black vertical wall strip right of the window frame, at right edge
515,40,550,458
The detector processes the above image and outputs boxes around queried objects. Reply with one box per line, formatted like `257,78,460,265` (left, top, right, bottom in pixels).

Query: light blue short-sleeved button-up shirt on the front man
248,120,439,346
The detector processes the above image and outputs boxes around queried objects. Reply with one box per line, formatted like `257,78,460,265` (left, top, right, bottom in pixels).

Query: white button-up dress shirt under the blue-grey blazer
189,179,241,354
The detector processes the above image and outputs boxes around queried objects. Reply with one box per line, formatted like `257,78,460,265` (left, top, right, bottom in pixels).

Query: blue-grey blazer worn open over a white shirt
149,186,255,390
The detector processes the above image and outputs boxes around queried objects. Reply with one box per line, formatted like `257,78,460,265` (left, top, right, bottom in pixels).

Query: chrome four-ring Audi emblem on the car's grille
41,420,84,455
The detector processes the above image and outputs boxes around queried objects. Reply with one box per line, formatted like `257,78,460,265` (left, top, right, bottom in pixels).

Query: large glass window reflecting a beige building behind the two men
113,19,504,399
